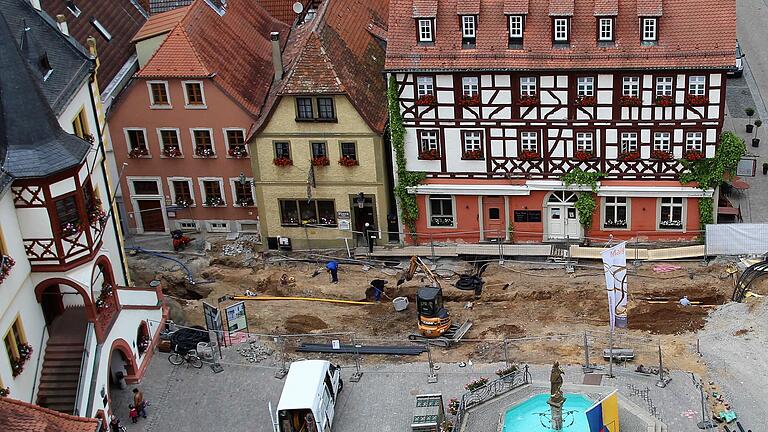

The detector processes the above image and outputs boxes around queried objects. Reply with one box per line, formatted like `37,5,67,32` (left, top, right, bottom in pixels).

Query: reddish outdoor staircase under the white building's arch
37,307,86,414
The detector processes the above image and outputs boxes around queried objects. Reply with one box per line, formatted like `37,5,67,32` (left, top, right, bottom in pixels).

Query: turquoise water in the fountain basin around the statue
503,394,594,432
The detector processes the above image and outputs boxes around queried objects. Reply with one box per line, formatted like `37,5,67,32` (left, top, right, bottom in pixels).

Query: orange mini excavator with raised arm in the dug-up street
397,256,472,347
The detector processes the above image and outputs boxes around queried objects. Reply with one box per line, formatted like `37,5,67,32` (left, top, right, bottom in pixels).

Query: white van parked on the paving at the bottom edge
269,360,344,432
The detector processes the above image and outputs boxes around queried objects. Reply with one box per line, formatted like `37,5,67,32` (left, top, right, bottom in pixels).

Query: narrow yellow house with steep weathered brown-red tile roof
249,0,390,249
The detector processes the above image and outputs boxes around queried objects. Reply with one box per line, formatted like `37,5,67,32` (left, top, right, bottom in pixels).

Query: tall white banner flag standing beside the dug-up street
601,242,627,328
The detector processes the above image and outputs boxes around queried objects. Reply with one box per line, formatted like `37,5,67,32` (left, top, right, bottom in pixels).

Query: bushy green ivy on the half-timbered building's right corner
680,132,747,229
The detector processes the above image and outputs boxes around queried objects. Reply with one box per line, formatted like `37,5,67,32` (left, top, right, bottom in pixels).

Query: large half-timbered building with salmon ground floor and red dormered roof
386,0,736,241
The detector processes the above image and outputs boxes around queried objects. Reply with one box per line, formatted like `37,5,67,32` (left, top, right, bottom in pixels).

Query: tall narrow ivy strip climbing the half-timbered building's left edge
387,75,426,234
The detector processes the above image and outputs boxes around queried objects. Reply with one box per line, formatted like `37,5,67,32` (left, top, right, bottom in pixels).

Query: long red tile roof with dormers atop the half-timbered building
386,0,736,70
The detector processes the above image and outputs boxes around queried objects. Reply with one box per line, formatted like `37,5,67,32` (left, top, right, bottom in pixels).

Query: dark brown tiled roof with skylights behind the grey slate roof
40,0,148,91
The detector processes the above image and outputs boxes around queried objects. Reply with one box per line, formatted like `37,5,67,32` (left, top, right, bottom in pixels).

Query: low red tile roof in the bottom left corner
0,397,99,432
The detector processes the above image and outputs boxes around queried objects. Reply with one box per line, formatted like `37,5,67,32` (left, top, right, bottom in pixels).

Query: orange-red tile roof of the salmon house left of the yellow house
137,0,289,115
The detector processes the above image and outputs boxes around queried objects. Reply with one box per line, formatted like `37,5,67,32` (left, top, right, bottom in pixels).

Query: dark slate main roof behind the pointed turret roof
0,0,95,116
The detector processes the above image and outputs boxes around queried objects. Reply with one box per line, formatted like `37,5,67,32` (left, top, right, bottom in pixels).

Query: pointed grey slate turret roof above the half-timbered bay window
0,9,91,192
